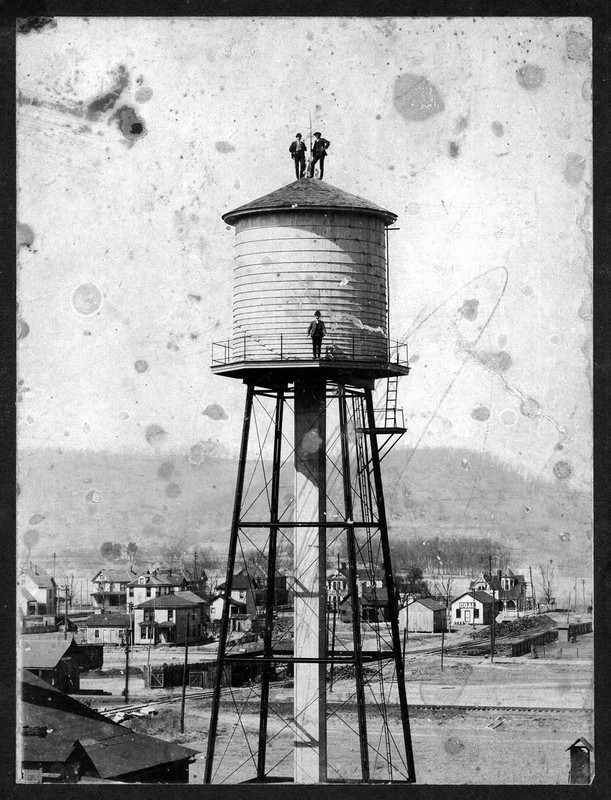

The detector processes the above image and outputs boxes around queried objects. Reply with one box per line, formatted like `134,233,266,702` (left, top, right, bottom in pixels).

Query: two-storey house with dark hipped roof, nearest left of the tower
134,591,208,645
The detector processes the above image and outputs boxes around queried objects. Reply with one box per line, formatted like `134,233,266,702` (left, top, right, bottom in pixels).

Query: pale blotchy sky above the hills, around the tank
17,17,592,492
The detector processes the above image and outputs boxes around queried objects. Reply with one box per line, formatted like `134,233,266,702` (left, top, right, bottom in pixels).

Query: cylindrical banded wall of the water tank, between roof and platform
233,211,387,361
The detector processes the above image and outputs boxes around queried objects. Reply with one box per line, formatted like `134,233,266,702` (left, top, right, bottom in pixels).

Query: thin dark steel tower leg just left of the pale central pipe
257,389,284,781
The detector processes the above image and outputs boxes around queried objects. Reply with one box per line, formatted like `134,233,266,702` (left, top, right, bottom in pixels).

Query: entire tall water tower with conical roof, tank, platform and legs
205,179,415,783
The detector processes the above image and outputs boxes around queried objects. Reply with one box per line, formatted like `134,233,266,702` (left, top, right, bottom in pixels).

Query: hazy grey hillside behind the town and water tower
18,448,591,576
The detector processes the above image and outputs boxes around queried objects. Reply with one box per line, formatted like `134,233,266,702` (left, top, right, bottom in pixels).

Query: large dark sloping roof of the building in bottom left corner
21,671,197,778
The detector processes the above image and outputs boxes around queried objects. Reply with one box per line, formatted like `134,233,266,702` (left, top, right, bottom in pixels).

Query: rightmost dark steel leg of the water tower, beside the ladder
365,389,416,783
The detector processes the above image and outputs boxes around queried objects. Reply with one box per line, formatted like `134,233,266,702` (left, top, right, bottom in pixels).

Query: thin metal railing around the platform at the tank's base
212,331,409,367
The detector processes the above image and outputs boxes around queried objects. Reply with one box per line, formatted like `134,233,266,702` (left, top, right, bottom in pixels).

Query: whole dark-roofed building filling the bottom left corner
18,670,197,783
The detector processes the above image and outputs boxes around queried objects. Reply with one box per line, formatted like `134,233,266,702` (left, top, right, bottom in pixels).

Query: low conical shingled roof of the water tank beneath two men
223,178,397,225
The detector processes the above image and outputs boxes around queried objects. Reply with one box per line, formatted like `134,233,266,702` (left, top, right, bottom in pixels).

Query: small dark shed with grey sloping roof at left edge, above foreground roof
20,635,90,692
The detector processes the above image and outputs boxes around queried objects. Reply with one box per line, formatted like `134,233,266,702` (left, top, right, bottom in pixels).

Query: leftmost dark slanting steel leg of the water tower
204,384,255,783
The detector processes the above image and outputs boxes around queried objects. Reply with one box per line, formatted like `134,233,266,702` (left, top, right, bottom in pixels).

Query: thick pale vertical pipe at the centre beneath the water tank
293,379,327,783
